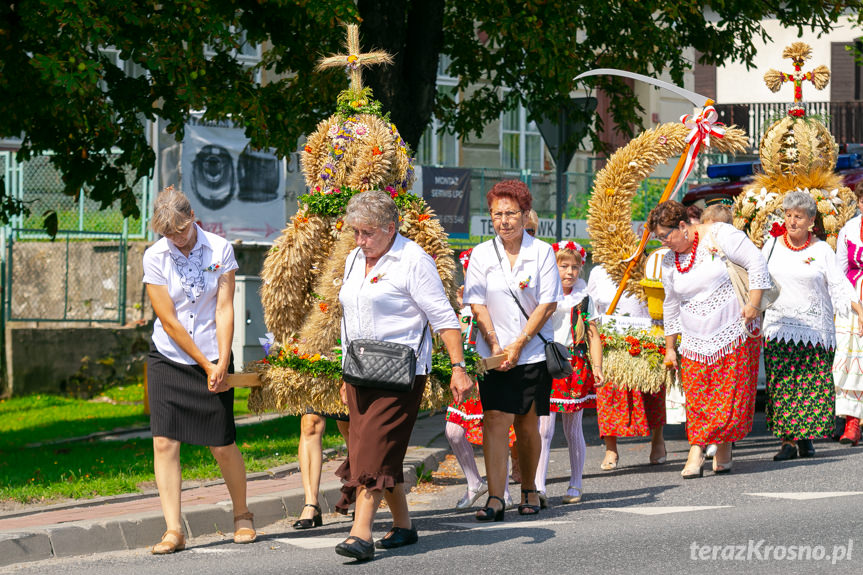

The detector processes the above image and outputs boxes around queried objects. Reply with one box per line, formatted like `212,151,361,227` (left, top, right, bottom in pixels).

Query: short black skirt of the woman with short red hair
479,361,551,415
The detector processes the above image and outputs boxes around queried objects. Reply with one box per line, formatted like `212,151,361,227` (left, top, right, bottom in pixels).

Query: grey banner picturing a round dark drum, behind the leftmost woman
181,115,286,243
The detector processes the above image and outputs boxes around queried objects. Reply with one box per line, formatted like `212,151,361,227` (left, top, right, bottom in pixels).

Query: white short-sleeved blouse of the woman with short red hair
464,232,563,365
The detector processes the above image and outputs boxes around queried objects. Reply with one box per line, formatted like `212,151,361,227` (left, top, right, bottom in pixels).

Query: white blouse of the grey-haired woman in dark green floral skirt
761,237,857,349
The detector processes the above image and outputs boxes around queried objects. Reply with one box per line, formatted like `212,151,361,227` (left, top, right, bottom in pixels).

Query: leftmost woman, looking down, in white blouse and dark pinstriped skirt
144,188,256,555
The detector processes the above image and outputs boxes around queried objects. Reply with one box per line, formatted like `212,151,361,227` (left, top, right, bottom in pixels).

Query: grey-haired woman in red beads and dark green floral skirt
762,191,863,461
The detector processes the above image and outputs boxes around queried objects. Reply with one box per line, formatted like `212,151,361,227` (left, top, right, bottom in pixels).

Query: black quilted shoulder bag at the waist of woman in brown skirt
342,252,429,392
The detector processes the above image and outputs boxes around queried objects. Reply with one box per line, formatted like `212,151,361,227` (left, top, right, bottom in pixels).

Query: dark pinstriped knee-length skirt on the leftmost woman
147,347,237,447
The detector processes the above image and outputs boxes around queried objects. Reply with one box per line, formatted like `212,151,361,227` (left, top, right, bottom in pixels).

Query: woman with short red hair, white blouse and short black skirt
464,180,563,521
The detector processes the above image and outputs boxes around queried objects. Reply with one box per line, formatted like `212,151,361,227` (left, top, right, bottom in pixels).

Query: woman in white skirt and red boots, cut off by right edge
833,184,863,445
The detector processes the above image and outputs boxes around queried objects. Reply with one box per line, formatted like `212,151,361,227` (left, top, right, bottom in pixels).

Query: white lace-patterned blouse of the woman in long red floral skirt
662,222,771,364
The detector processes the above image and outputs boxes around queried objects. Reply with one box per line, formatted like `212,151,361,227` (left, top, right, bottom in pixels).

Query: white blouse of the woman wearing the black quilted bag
339,233,459,375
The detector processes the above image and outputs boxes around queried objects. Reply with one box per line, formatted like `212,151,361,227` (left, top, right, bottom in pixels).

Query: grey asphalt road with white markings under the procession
0,417,863,575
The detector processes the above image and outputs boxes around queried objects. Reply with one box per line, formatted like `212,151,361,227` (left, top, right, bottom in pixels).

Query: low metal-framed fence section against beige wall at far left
3,228,126,324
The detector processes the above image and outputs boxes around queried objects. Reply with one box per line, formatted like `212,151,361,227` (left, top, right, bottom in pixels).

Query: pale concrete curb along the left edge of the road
0,447,449,567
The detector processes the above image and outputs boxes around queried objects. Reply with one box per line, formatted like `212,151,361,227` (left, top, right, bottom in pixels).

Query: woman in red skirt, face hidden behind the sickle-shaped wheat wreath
587,265,667,471
